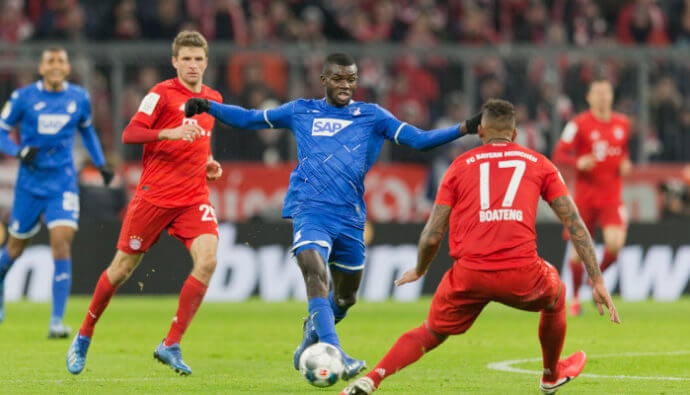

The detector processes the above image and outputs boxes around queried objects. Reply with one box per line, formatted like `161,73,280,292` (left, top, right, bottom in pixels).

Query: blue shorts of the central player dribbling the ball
292,214,364,273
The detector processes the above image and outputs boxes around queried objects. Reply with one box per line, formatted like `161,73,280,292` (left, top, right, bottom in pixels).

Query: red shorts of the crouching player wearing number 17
427,259,565,335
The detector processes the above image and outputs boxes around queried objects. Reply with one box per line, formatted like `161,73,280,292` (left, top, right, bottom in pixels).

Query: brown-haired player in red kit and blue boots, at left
67,31,222,375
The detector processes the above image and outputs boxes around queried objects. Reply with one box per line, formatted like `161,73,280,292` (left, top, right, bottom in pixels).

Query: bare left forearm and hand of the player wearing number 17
395,204,451,285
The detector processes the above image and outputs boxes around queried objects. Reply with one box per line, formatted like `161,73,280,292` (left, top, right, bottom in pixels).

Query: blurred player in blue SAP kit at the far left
0,47,113,338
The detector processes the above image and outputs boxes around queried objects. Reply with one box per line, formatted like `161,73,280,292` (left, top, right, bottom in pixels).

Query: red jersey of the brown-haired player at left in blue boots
130,78,223,207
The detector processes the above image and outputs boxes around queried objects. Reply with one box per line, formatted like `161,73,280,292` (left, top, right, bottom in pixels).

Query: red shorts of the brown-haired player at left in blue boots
117,195,218,254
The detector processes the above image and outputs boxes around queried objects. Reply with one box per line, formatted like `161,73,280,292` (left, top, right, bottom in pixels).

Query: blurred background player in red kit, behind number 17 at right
553,79,632,315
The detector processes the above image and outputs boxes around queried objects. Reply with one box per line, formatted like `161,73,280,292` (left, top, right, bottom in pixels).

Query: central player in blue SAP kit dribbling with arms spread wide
187,54,479,379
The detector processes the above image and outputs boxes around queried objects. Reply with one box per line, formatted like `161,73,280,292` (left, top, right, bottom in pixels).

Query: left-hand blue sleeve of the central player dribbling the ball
208,101,294,130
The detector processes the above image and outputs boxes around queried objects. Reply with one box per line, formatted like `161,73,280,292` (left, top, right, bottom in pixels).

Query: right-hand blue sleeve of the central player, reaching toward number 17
377,106,461,149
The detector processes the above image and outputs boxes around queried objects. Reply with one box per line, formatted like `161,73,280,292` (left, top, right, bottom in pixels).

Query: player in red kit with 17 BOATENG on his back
341,99,620,395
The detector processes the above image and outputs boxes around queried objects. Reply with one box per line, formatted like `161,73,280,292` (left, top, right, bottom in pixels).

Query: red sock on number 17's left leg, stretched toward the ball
367,325,441,387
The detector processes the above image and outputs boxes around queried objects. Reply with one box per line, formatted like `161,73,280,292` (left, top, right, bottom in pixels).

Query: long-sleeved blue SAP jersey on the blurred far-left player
0,81,105,196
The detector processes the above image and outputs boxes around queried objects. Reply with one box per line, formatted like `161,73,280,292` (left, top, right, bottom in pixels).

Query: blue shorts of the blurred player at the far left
8,188,79,239
